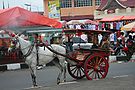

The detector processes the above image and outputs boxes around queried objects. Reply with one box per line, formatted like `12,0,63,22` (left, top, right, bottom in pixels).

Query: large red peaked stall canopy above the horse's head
0,7,62,28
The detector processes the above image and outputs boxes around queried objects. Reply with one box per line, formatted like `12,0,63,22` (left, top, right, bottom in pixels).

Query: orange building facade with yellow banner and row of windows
44,0,101,21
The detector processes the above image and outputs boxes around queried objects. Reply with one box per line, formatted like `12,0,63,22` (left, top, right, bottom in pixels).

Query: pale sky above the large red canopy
0,0,44,11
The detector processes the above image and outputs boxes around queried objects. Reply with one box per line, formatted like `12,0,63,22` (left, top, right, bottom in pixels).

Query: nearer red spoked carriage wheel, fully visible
84,54,109,80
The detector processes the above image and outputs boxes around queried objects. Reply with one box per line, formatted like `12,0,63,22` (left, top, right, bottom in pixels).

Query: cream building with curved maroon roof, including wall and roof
94,0,135,19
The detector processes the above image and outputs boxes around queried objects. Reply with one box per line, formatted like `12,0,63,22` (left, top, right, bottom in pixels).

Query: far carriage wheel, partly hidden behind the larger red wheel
67,63,85,79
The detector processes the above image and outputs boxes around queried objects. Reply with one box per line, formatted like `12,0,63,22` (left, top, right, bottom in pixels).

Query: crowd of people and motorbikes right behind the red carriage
109,32,135,54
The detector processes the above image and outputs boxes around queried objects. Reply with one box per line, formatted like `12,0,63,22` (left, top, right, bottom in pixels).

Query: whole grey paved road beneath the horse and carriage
0,62,135,90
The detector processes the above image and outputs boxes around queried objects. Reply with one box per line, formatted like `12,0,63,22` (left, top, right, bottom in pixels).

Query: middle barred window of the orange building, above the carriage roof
74,0,92,7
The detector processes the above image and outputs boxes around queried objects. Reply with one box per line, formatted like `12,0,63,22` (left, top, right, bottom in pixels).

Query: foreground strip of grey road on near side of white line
28,76,135,90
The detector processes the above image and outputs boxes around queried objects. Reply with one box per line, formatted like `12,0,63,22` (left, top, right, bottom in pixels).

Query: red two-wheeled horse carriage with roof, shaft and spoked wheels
47,29,110,80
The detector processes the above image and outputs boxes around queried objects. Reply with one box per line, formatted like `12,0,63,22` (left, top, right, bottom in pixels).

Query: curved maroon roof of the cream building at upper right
97,0,135,10
